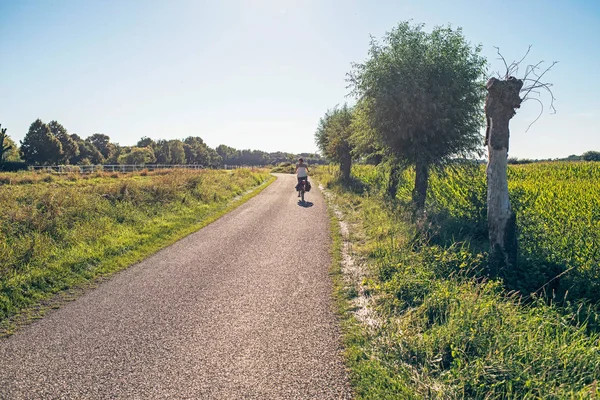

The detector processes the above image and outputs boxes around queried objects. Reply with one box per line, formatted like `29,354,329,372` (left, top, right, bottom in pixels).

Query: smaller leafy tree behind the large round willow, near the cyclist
315,104,353,179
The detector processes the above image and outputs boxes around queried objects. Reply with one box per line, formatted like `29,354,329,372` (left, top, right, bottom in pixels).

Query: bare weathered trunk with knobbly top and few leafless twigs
485,77,523,275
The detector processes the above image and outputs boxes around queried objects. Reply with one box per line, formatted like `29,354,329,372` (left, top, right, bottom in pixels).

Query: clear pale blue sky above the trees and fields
0,0,600,158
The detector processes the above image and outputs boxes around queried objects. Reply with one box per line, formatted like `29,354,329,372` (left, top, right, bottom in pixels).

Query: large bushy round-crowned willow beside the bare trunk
348,22,486,209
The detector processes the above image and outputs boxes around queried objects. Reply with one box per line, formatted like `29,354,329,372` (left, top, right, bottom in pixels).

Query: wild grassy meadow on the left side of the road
0,169,275,336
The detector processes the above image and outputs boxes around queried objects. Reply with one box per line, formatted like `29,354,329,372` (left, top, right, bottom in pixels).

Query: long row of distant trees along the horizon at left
0,119,326,169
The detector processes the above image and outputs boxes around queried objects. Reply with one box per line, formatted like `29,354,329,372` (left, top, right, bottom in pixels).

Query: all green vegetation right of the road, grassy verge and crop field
317,163,600,399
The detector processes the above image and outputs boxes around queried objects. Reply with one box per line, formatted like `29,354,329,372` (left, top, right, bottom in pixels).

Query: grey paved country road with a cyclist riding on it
0,175,351,399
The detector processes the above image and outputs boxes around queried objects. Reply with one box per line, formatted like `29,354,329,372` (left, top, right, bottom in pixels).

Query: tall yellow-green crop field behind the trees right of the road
346,162,600,303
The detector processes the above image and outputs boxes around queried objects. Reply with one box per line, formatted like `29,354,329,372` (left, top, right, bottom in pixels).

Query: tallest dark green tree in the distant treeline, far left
21,119,62,165
